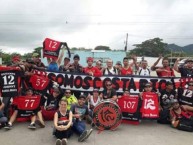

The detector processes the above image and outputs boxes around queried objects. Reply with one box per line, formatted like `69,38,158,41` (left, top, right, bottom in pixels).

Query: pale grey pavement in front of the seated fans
0,121,193,145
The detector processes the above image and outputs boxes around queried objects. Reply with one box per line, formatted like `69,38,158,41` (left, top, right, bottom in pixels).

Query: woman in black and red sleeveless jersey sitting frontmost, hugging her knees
54,99,72,145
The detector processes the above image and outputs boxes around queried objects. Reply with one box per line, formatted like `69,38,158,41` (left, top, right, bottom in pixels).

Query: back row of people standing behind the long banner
48,54,193,77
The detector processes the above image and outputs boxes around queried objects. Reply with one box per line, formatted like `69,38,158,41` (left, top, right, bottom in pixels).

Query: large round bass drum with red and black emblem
93,100,122,130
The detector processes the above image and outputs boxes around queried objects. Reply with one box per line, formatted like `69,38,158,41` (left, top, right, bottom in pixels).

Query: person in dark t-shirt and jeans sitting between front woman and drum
71,95,92,142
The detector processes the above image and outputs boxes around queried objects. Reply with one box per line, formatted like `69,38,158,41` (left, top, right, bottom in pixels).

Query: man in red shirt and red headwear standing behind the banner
83,57,102,77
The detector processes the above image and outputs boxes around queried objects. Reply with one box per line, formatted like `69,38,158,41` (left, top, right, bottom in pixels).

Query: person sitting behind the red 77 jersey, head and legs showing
4,88,40,130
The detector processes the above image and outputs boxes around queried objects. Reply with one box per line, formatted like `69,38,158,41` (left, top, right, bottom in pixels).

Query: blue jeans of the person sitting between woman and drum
72,120,86,135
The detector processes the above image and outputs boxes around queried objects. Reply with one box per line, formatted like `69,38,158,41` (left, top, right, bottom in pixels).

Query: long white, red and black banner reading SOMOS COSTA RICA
47,72,193,93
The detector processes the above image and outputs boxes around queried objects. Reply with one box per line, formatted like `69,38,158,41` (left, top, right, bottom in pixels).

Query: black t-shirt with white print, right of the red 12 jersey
160,90,177,109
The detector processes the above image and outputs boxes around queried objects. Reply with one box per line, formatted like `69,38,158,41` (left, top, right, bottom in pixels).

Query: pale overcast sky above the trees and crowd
0,0,193,54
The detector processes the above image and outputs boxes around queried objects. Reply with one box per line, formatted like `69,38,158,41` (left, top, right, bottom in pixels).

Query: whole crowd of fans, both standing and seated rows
0,53,193,145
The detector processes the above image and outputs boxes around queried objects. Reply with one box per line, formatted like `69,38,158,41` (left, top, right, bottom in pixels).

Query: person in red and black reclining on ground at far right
170,99,193,132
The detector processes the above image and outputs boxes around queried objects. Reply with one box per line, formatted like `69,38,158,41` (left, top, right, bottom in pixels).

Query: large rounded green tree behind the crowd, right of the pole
130,38,170,57
